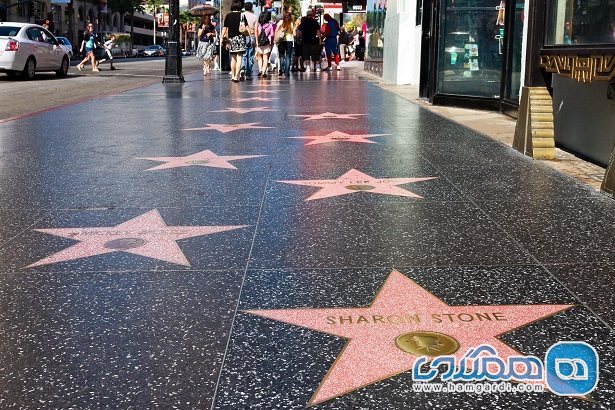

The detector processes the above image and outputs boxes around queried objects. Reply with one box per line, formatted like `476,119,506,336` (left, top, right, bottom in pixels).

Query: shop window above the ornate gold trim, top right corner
547,0,615,46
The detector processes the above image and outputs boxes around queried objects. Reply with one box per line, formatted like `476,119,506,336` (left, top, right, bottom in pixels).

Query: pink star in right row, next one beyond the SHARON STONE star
277,169,438,201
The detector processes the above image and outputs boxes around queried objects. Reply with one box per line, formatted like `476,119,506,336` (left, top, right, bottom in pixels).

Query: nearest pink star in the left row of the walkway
27,209,248,268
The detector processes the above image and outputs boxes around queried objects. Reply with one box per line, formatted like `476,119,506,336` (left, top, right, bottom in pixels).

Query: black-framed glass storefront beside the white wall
417,0,525,113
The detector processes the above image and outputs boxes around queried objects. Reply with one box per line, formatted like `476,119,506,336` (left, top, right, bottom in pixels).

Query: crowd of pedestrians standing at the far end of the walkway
196,0,365,82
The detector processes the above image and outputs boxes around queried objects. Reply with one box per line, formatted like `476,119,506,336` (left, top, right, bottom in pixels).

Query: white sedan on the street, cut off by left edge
0,22,70,80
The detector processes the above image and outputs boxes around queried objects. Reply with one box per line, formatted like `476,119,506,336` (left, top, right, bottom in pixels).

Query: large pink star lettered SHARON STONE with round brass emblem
245,270,573,405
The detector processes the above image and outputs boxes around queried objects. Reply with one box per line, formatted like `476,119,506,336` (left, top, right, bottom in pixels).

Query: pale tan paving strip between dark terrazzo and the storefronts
347,64,606,191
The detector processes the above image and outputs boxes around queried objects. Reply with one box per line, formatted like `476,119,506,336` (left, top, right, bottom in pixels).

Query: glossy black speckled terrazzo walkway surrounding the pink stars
0,67,615,409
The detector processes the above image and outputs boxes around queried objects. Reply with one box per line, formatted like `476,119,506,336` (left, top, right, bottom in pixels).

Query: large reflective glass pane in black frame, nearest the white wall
437,0,505,98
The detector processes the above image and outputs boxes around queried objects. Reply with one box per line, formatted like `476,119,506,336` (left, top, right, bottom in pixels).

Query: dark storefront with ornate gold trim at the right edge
540,0,615,181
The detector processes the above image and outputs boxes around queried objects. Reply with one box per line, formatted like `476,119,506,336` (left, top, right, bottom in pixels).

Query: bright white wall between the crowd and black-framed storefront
382,0,421,86
